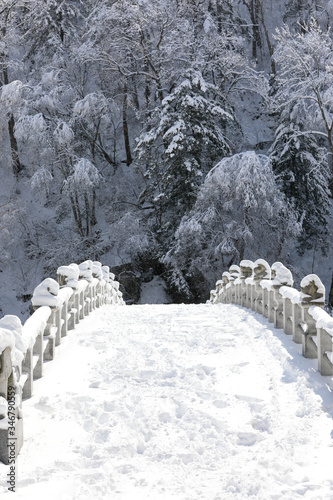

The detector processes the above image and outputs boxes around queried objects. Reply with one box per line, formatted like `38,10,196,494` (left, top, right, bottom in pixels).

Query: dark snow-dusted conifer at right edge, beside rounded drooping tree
271,115,331,254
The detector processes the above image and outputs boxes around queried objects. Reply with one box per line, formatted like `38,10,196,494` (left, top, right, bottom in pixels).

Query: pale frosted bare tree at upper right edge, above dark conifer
273,20,333,166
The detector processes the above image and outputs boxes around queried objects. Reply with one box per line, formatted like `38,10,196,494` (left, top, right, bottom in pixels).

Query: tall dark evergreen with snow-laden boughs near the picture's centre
137,70,233,237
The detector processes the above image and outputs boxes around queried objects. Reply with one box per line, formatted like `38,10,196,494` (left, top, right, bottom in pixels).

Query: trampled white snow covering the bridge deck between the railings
0,305,333,500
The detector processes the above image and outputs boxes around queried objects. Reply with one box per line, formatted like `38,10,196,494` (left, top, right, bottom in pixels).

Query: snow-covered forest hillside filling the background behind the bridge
0,0,333,316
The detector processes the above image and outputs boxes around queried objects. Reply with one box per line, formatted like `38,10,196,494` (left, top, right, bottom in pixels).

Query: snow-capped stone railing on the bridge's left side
0,260,124,463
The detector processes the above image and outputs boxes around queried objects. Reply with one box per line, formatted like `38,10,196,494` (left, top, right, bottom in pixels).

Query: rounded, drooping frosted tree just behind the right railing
164,151,300,300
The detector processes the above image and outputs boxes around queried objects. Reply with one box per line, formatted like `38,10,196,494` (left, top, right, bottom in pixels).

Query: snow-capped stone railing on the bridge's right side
210,259,333,376
